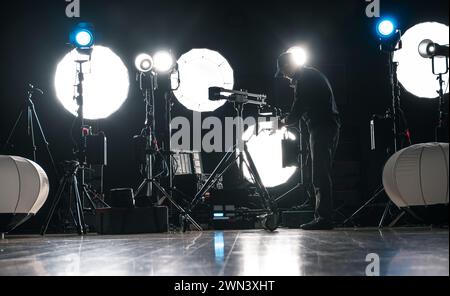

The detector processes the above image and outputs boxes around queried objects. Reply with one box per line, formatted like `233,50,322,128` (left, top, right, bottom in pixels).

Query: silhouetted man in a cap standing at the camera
276,53,340,230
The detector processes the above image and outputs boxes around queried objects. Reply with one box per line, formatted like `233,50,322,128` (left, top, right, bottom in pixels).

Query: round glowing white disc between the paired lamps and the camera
172,49,234,112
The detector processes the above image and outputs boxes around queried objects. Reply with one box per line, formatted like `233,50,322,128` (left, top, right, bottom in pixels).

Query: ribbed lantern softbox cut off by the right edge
383,143,449,208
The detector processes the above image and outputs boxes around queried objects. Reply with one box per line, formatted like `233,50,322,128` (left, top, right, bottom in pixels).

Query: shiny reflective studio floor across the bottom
0,228,449,276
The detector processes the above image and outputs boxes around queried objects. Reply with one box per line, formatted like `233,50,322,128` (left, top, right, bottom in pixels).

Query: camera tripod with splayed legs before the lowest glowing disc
189,93,278,231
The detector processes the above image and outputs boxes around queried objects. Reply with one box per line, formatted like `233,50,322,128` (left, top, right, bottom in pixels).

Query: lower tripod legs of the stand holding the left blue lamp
41,161,87,235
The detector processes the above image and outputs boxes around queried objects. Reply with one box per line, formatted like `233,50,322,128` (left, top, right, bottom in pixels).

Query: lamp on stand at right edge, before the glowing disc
418,39,449,142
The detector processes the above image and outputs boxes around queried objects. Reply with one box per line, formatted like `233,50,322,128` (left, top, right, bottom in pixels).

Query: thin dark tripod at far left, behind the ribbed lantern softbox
3,84,58,176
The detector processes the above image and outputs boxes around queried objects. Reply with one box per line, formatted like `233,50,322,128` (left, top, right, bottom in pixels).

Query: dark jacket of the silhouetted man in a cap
286,67,340,130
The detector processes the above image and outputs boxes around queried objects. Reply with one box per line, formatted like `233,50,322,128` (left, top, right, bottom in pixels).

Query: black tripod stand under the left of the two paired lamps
134,72,203,231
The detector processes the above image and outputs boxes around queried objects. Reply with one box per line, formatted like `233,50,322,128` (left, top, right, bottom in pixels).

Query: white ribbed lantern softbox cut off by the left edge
0,155,50,233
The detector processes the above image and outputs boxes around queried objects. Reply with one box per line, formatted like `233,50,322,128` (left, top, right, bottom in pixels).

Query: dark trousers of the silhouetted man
309,125,340,221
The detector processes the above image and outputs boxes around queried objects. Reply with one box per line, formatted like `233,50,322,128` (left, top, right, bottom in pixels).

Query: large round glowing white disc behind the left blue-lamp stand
55,46,130,119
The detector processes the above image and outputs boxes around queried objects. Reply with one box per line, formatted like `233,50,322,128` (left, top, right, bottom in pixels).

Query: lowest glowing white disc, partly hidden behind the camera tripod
242,122,297,188
